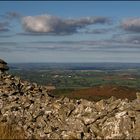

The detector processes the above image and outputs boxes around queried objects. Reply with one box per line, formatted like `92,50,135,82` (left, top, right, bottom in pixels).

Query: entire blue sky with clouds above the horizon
0,1,140,63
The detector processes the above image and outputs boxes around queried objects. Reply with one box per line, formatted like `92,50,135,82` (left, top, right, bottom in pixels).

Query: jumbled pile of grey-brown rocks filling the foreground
0,73,140,139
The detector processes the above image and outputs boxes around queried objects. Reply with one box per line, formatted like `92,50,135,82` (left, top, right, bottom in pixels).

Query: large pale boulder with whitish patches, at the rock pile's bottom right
102,112,132,139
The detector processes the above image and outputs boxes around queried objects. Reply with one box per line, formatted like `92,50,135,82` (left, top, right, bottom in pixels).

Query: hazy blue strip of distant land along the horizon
9,62,140,70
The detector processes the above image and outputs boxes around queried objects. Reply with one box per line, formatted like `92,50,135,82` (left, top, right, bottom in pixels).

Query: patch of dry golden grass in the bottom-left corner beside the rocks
0,123,25,139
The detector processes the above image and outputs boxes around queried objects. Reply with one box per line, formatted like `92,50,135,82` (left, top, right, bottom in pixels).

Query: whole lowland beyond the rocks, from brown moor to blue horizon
10,63,140,100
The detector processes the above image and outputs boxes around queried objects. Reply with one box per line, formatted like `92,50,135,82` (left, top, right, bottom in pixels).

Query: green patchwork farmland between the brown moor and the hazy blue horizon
10,69,140,89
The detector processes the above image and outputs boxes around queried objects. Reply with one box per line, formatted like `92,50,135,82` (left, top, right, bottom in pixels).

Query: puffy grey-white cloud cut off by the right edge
121,18,140,33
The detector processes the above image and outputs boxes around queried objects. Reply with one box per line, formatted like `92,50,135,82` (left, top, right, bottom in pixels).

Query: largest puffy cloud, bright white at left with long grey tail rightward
22,14,111,35
